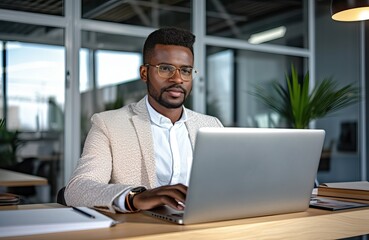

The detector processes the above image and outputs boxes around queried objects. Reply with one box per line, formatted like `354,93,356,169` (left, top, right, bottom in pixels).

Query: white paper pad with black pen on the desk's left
0,207,115,237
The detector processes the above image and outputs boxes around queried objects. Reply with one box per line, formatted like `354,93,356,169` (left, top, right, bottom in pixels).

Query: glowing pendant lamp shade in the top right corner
331,0,369,22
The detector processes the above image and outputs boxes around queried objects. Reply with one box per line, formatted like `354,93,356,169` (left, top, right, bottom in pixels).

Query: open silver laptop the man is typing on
145,128,325,224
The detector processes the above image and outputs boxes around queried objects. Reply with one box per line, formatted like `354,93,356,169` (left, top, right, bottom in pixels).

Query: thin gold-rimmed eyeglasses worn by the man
145,64,197,81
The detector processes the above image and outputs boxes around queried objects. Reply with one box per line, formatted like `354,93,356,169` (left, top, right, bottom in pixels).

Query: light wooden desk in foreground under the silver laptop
0,204,369,240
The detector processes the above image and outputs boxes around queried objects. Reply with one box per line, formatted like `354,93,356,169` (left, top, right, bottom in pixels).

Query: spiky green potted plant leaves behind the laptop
251,65,360,128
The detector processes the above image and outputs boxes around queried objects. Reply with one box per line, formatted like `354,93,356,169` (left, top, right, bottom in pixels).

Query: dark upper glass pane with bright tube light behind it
206,0,308,48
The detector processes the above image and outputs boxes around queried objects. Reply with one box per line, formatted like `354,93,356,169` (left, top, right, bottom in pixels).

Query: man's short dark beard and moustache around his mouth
146,76,191,108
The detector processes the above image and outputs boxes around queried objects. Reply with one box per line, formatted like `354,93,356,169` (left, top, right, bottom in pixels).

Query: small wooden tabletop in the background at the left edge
0,169,47,187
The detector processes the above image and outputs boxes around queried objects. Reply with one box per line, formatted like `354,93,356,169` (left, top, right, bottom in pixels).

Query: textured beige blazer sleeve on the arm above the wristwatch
65,114,130,212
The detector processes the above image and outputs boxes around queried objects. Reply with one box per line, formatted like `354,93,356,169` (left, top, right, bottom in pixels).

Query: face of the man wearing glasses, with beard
140,44,193,110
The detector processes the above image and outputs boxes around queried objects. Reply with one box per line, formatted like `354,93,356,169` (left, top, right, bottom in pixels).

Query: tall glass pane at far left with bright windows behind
0,21,65,203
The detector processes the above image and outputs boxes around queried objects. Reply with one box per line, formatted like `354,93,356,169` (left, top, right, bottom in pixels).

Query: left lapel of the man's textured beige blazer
132,98,156,188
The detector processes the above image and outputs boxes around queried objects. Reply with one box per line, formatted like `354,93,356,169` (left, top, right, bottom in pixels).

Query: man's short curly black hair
143,27,195,63
